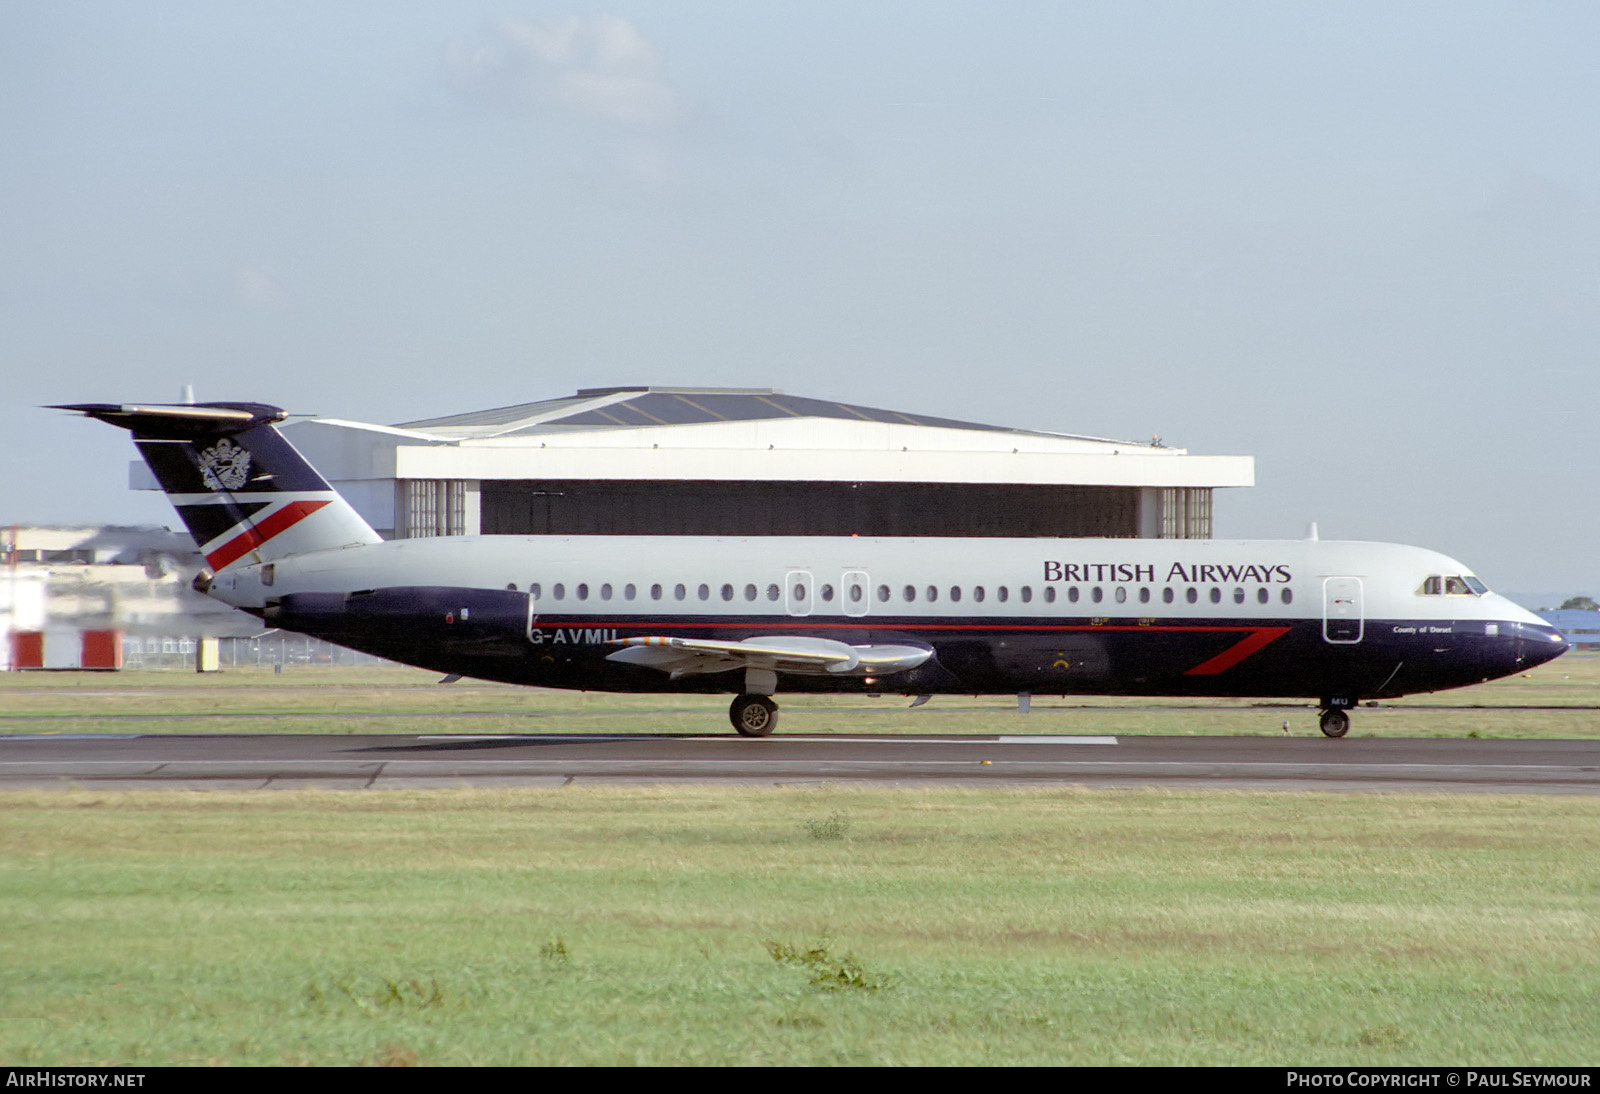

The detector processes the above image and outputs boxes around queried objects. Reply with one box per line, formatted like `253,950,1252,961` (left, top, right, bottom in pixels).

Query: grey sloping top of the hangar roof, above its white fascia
398,380,1126,445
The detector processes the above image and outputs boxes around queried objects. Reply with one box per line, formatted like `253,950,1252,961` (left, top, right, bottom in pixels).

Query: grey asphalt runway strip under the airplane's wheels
0,734,1600,793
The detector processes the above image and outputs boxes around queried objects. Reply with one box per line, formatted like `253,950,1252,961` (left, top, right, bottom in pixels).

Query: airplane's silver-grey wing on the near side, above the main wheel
606,635,933,680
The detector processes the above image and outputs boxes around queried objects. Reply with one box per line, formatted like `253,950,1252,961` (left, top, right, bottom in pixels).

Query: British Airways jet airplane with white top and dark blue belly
51,403,1568,737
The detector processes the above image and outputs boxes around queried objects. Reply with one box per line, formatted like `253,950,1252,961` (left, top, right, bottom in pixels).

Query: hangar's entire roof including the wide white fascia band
249,385,1254,496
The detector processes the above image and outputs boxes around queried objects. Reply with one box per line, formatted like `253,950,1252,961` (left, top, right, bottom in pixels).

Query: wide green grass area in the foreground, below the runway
0,787,1600,1065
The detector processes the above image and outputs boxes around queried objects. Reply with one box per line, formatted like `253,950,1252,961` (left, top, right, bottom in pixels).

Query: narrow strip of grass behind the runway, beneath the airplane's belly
0,654,1600,739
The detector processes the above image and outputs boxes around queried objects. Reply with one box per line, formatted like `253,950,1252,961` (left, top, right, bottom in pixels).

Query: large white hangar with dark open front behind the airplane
134,387,1254,539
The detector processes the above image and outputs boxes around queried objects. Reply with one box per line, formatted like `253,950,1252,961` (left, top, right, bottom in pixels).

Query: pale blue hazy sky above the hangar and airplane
0,0,1600,595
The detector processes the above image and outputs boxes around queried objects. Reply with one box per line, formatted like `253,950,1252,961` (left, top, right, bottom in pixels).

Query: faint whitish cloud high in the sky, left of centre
445,14,682,126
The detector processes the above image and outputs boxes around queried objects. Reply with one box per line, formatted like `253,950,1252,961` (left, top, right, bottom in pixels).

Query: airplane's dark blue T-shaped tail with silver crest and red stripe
51,403,379,571
